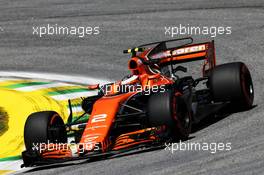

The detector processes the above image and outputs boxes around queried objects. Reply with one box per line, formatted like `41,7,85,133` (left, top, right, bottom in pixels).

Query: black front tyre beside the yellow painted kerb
24,111,67,151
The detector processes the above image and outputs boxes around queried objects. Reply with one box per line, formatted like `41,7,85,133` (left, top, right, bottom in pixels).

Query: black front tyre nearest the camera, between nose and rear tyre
147,90,192,140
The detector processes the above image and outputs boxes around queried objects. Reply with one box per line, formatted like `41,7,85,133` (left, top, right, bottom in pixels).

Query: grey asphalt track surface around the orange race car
0,0,264,174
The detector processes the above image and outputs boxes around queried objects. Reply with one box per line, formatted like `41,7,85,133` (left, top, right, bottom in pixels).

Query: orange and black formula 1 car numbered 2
22,38,254,167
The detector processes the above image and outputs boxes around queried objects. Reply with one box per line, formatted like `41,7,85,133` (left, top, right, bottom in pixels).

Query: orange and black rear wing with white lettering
146,40,216,75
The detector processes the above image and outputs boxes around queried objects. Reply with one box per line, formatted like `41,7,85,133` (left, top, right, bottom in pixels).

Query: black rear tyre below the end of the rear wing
209,62,254,109
